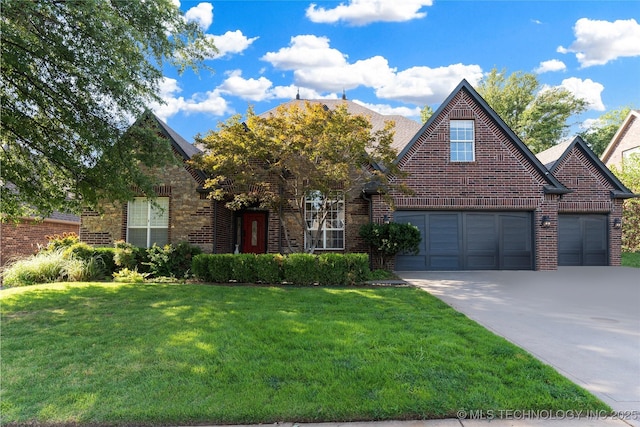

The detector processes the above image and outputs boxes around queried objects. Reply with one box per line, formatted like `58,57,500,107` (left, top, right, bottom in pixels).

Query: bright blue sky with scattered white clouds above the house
153,0,640,141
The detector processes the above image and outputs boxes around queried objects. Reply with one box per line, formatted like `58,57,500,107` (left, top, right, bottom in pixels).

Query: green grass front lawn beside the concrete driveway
0,283,609,425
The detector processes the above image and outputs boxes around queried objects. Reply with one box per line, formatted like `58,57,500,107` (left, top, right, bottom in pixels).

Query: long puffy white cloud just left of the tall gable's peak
262,35,482,105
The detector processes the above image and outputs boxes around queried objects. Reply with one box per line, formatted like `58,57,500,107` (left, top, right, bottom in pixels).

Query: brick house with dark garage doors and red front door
80,81,633,270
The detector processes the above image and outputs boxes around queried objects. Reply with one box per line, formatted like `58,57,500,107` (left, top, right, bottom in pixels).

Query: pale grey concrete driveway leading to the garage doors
398,267,640,426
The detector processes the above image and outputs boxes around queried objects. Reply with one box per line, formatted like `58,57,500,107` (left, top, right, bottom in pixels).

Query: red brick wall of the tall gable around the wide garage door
380,90,557,270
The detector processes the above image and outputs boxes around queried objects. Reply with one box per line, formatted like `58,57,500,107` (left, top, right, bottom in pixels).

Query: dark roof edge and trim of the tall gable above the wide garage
396,79,571,194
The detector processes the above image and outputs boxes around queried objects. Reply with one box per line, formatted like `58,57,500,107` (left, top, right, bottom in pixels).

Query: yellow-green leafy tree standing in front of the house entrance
196,102,403,253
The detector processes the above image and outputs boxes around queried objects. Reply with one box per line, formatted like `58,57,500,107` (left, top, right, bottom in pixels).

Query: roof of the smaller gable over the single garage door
538,136,636,199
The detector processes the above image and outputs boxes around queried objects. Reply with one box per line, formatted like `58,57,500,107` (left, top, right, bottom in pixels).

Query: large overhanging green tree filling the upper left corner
0,0,215,220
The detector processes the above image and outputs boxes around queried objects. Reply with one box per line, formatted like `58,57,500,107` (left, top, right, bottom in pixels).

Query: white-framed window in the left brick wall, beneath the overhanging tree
127,197,169,248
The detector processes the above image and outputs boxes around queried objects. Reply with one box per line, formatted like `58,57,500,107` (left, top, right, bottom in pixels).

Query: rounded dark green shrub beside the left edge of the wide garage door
360,222,422,268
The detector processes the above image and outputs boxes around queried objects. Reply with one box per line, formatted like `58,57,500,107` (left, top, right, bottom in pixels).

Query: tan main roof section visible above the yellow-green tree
260,99,422,152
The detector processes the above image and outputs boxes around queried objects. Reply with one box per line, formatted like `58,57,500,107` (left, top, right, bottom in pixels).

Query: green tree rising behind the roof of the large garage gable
477,68,587,153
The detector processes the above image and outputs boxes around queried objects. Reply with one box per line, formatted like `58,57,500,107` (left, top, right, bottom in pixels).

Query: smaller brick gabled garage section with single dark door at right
537,137,634,265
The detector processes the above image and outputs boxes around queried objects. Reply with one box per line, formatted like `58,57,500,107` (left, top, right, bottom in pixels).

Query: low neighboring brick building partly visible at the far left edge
0,212,80,268
